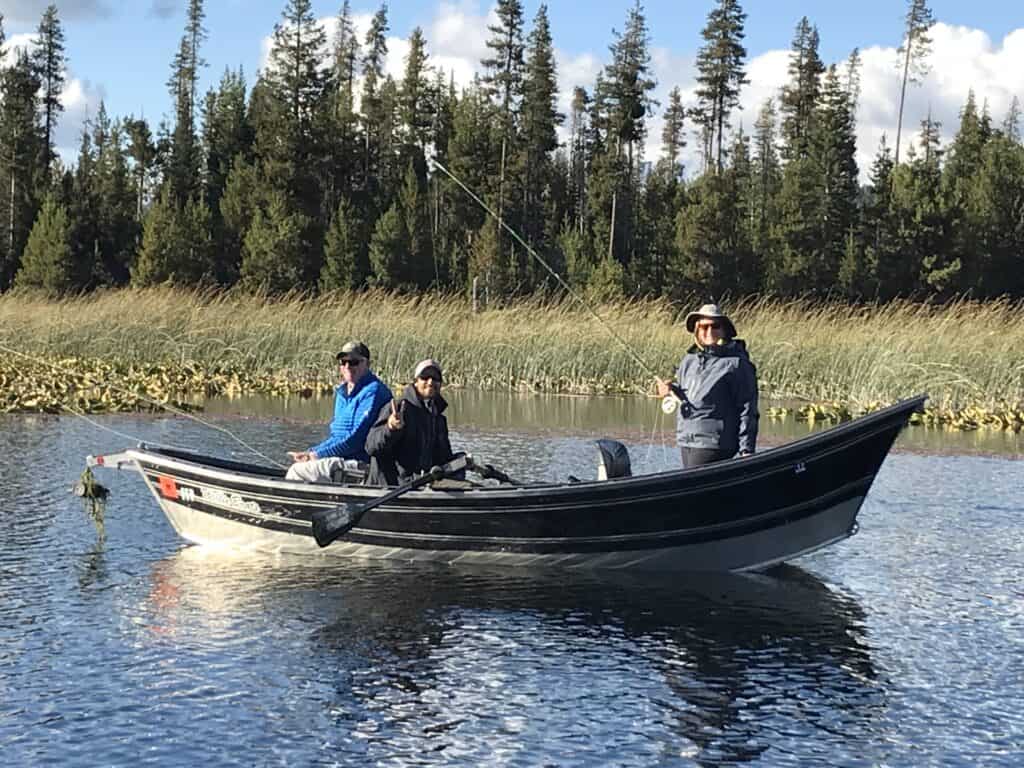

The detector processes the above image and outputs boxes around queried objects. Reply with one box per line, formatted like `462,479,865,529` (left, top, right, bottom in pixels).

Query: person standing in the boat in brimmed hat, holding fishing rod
655,304,760,468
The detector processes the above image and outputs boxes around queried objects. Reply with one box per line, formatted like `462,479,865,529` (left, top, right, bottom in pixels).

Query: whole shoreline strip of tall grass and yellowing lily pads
0,288,1024,431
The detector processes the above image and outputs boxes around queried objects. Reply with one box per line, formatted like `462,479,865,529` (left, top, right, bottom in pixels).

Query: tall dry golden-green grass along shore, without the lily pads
0,289,1024,408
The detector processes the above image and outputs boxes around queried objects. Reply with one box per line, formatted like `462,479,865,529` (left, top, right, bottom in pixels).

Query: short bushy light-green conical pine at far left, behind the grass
14,196,74,295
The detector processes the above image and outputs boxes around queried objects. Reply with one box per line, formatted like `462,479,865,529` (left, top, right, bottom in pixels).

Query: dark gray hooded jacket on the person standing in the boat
676,339,759,454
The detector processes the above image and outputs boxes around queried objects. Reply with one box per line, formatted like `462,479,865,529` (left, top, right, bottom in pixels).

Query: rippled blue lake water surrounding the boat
0,393,1024,766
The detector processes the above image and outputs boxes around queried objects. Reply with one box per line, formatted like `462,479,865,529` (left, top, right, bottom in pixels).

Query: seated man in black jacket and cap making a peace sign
367,359,455,485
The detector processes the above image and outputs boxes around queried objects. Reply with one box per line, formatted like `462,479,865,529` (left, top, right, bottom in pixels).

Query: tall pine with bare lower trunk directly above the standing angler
694,0,750,173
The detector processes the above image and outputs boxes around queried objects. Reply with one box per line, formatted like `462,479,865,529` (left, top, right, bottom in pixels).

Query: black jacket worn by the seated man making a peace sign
367,384,454,485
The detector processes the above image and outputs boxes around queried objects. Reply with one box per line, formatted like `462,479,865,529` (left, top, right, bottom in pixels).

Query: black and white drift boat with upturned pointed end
87,395,926,571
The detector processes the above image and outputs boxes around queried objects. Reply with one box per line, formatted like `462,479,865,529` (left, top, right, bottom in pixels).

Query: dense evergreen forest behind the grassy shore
0,0,1024,305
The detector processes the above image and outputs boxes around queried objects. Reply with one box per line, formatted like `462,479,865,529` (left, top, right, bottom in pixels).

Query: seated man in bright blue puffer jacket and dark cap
286,341,391,482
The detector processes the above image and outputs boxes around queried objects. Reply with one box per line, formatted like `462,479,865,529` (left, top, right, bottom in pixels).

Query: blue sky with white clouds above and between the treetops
0,0,1024,178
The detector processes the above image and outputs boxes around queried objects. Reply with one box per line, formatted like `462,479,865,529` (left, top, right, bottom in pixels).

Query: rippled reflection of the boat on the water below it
142,547,885,765
